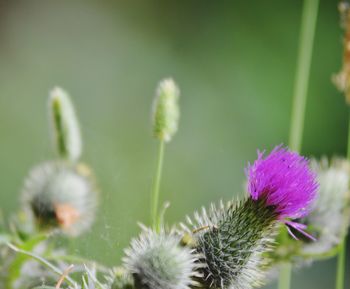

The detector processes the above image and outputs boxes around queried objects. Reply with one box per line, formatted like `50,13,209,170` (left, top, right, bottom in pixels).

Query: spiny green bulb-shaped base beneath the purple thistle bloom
182,198,277,289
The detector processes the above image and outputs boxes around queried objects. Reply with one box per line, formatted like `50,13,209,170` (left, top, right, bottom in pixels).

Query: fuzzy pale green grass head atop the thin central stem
153,79,180,142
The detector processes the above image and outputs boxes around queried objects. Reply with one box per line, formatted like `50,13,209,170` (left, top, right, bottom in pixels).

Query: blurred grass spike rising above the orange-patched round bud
49,87,82,162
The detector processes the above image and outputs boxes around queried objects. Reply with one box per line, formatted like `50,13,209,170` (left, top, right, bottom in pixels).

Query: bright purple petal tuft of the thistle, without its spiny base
246,145,318,237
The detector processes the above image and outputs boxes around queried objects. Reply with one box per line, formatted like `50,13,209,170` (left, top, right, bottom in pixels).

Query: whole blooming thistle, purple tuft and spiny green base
189,146,317,289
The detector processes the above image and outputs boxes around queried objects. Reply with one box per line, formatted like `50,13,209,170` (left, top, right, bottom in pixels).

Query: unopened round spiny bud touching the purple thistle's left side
124,228,197,289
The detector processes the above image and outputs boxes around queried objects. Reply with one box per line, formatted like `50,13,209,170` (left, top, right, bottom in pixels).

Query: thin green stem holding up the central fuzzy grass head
151,140,165,231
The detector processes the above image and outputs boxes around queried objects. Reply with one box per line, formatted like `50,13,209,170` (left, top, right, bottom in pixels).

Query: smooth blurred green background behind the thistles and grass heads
0,0,350,289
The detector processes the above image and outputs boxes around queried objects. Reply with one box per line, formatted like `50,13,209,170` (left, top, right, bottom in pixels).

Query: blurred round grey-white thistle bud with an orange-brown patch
22,161,96,235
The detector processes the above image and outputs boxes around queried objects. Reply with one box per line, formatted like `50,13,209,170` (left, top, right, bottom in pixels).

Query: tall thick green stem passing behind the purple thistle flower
278,0,319,289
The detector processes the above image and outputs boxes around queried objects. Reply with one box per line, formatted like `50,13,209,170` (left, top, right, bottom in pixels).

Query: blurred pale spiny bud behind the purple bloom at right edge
303,158,350,254
